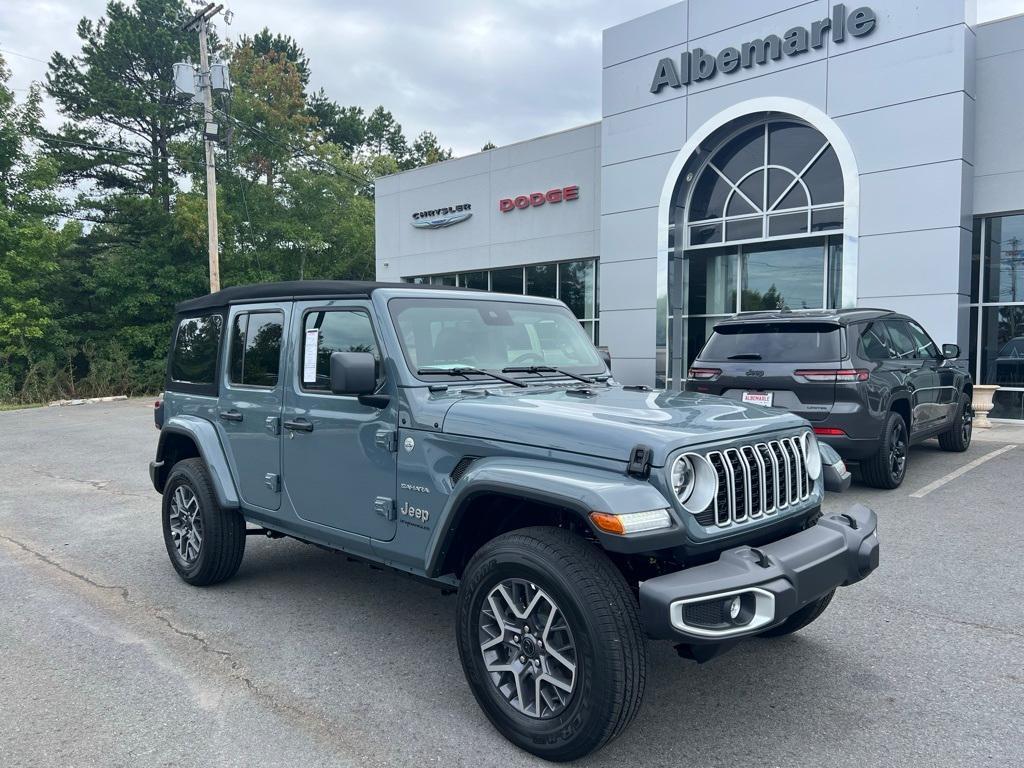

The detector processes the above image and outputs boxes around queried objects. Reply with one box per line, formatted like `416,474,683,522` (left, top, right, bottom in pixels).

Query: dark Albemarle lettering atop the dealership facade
650,3,879,93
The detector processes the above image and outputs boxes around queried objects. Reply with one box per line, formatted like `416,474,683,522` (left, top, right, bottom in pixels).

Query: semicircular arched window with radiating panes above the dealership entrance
686,119,843,248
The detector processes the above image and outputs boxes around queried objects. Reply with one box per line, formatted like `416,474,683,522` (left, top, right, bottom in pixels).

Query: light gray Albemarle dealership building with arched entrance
376,0,1024,418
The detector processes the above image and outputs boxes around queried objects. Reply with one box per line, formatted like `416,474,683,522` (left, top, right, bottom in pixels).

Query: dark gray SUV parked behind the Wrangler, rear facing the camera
686,309,973,488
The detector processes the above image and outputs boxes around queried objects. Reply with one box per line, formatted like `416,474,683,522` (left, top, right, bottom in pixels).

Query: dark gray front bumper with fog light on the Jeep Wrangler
640,504,879,644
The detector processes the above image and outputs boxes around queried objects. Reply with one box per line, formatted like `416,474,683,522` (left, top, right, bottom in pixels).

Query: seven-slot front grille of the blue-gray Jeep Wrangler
696,436,814,528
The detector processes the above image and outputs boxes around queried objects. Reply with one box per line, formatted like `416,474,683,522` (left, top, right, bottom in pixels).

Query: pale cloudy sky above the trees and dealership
0,0,1024,155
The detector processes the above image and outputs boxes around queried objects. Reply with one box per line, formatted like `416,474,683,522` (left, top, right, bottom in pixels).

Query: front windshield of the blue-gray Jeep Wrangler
388,298,605,381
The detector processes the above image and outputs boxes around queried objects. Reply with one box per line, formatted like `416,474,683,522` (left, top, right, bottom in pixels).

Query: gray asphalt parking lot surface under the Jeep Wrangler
0,400,1024,768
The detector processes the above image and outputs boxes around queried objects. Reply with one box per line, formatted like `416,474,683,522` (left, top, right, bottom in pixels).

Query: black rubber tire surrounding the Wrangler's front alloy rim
457,527,647,762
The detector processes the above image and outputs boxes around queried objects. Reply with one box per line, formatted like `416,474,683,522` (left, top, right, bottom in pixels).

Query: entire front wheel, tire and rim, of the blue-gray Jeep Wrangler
457,527,647,762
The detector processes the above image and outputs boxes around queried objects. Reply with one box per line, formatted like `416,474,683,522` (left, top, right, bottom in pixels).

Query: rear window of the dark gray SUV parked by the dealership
697,323,843,362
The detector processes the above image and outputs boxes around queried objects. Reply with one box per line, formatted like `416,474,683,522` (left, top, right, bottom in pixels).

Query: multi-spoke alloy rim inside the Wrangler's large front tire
479,579,577,719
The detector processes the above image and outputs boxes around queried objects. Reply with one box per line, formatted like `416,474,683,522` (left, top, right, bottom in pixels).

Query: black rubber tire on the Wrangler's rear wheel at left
162,459,246,587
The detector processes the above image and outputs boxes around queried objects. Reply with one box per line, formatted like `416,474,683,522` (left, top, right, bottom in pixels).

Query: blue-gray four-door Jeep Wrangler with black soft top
150,282,879,761
